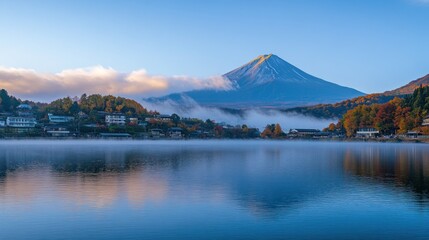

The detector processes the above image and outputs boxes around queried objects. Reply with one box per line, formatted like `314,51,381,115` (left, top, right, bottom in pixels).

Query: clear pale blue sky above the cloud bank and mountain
0,0,429,99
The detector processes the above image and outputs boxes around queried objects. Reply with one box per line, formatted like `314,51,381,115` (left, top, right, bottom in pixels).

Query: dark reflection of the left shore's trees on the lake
0,145,204,173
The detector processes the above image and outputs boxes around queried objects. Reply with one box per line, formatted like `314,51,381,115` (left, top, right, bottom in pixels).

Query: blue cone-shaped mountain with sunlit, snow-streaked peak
147,54,365,108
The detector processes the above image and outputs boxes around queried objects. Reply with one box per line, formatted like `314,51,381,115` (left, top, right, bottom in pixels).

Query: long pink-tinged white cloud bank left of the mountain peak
0,66,232,101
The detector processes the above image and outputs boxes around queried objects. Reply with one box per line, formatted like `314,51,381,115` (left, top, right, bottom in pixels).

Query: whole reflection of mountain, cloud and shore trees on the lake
4,142,429,216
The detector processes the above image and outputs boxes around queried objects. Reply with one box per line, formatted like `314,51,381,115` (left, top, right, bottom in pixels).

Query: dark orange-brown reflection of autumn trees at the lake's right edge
343,145,429,197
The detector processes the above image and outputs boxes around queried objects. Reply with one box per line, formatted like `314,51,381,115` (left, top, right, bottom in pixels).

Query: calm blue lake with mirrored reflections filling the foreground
0,140,429,239
